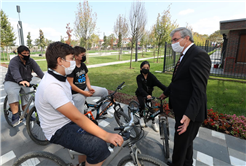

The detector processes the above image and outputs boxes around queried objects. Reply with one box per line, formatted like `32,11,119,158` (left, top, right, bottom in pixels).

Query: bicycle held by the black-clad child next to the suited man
128,96,170,159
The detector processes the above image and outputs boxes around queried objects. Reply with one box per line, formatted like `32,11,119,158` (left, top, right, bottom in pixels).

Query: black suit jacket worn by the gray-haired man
164,45,211,122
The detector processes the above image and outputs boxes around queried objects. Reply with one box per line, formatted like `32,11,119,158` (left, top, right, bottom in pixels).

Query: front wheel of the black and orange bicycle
114,108,140,139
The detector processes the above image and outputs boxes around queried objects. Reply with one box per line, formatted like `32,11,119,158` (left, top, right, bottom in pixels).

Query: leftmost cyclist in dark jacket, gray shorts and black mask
4,46,44,127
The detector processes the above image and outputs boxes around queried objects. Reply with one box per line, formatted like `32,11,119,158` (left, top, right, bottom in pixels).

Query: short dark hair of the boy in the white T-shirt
45,42,74,69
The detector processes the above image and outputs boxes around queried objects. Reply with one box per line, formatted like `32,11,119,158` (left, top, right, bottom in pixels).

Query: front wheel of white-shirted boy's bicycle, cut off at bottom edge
118,154,167,166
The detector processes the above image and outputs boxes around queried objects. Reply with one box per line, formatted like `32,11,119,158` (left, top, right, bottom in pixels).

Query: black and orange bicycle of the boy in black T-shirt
84,82,138,138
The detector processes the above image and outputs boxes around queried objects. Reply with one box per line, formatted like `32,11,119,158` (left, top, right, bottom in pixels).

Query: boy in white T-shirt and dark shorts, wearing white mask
35,42,123,166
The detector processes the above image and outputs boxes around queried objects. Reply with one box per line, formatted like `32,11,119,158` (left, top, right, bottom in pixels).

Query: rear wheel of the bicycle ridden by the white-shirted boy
13,151,67,166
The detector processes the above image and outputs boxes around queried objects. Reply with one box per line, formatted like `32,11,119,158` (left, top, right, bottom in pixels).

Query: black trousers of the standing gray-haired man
172,117,202,166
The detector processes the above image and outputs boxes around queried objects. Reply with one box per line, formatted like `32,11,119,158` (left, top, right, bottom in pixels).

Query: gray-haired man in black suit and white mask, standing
160,27,211,166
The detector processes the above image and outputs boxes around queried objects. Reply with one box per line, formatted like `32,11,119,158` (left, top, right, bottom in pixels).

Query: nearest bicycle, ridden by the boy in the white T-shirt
13,113,167,166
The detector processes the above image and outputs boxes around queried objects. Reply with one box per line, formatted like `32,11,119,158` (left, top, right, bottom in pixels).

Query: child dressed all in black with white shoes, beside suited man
135,61,166,132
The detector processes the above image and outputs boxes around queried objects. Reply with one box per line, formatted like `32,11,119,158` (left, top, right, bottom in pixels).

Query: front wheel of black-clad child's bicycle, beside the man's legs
159,121,169,159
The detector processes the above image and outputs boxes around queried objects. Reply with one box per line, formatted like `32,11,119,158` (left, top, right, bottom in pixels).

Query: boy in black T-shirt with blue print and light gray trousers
67,46,113,118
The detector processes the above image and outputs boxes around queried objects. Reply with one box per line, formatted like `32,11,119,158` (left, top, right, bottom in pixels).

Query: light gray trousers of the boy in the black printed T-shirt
73,86,108,114
